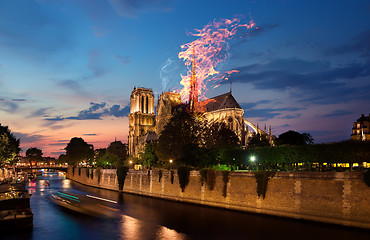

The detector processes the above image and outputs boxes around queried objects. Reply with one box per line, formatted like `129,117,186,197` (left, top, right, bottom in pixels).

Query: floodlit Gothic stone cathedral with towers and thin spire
128,50,271,156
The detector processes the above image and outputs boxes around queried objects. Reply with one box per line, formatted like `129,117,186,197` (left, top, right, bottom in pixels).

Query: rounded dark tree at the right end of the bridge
65,137,94,166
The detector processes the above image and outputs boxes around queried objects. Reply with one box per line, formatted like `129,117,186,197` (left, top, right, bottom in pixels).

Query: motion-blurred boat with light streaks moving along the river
50,191,119,218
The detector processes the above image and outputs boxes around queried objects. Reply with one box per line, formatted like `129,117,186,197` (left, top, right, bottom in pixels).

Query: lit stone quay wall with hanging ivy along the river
67,167,370,229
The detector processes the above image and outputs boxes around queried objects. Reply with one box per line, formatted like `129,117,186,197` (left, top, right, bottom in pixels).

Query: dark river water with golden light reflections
0,173,370,240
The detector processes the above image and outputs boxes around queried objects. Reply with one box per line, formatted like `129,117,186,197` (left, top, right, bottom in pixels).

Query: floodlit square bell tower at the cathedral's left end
128,87,155,156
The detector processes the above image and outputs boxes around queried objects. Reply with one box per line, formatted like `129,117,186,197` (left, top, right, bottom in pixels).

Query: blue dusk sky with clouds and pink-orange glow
0,0,370,157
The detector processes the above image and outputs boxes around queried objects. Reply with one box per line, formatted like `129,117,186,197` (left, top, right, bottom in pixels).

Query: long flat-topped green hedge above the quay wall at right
243,140,370,171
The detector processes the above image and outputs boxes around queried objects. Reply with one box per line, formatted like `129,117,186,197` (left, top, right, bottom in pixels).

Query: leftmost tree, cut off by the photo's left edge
0,124,21,166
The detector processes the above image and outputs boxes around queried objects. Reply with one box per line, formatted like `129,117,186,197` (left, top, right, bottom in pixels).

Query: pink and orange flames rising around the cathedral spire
178,18,256,107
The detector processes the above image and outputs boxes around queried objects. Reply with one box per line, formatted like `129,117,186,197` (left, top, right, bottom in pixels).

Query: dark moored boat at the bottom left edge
0,183,33,230
